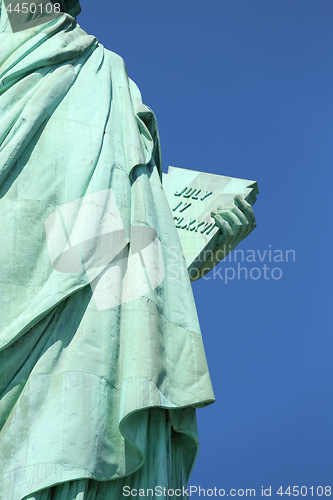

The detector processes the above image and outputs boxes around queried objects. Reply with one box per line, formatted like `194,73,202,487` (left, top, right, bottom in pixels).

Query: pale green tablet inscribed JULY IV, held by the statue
163,166,259,281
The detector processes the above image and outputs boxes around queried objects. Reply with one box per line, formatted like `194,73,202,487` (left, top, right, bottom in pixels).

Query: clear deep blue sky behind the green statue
79,0,333,498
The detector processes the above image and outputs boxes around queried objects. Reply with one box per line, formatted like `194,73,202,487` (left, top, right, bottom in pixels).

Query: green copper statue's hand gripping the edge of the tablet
211,195,257,248
